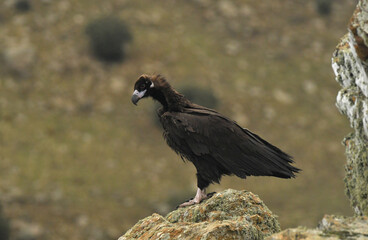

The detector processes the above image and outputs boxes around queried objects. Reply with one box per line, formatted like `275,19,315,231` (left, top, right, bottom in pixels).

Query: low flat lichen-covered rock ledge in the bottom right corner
266,215,368,240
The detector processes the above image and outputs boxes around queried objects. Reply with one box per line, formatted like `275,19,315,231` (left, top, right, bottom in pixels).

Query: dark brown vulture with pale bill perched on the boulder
132,75,300,207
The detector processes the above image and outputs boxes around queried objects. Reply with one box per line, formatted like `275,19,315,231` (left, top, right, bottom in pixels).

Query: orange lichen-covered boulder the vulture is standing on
119,189,280,240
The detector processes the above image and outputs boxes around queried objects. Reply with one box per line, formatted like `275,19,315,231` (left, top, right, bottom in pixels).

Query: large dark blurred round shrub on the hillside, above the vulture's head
86,16,132,62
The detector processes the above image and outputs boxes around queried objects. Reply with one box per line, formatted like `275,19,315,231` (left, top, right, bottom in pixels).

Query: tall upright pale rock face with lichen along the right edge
332,0,368,216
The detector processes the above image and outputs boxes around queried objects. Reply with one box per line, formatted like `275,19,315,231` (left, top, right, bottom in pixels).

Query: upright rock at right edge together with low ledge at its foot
266,0,368,240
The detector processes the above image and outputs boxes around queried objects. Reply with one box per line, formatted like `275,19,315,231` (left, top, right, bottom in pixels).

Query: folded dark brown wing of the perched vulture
161,105,298,178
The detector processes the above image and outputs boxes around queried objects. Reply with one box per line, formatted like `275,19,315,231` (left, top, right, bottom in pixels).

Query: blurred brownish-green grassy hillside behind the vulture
0,0,356,239
